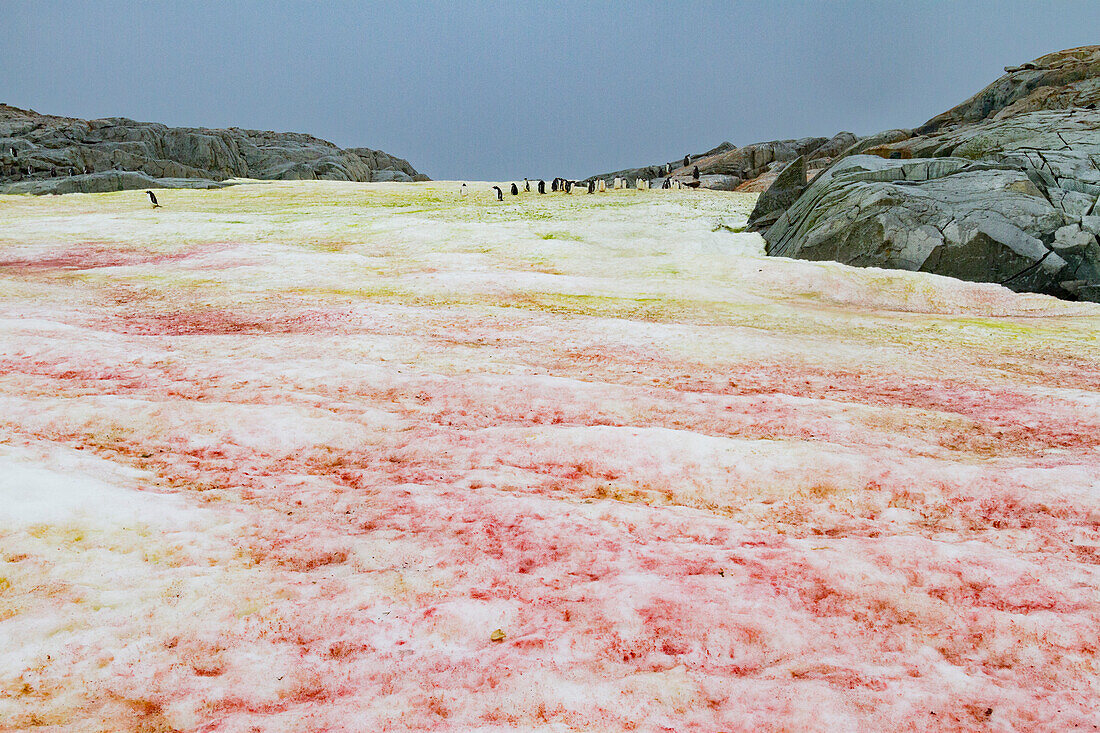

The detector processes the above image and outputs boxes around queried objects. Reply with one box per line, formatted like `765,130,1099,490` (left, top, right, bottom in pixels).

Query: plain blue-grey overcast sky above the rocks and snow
0,0,1100,179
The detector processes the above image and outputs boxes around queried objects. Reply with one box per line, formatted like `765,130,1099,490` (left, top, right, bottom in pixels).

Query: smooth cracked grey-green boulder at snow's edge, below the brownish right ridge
765,155,1100,297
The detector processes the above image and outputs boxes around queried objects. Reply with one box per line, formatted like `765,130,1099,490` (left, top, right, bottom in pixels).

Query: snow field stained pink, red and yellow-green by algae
0,182,1100,733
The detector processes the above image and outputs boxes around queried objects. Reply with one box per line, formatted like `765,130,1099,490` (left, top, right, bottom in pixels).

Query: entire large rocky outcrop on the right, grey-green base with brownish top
754,46,1100,300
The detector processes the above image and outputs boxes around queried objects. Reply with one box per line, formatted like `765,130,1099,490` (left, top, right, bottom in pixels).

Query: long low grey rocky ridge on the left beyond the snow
0,105,418,193
